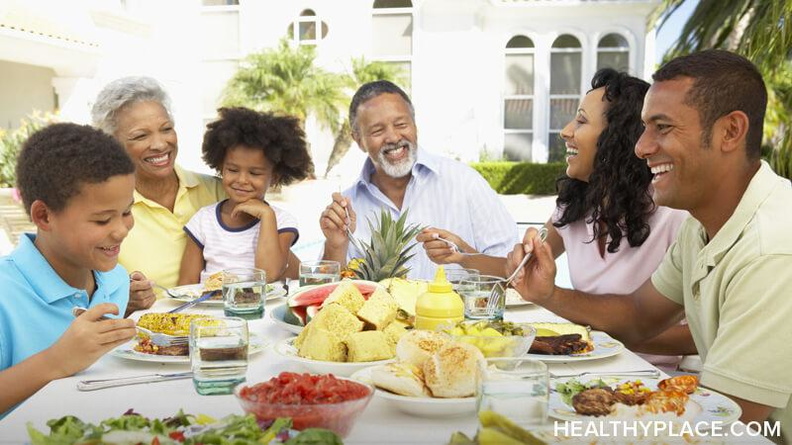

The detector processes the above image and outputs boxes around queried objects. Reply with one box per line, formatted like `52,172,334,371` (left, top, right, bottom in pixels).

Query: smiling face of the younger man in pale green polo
635,77,721,212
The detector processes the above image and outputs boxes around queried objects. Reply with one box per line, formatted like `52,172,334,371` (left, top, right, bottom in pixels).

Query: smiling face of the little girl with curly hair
222,145,276,204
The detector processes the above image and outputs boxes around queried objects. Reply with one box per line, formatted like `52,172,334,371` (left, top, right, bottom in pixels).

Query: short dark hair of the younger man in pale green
652,49,767,160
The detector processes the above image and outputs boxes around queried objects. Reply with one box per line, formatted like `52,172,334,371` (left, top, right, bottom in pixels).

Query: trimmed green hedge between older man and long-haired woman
470,161,566,195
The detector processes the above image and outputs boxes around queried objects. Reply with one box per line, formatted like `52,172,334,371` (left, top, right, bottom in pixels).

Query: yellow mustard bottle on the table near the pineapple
415,266,465,331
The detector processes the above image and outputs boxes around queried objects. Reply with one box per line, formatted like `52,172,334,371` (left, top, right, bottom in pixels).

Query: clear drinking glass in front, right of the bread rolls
476,358,550,430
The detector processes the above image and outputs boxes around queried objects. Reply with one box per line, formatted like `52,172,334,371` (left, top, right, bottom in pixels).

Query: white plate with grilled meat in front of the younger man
548,376,742,425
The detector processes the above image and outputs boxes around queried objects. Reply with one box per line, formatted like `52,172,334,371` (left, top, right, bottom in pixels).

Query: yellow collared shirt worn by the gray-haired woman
118,166,225,287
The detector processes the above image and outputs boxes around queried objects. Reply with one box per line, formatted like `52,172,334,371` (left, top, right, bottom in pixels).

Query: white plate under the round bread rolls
352,366,476,418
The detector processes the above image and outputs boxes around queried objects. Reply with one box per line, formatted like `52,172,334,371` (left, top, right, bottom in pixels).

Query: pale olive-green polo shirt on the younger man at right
652,161,792,443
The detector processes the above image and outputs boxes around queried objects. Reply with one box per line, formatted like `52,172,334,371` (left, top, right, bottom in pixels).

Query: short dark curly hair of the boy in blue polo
16,123,135,215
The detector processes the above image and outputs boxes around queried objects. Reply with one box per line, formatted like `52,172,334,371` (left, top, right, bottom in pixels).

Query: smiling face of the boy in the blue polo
42,174,135,277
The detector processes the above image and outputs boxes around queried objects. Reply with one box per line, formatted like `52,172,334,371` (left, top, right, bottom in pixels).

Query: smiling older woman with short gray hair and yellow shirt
91,77,225,310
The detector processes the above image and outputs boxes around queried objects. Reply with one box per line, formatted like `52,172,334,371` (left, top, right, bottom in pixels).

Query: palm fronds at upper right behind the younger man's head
652,0,792,178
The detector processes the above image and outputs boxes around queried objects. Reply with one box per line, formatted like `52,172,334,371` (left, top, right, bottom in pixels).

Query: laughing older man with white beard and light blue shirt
319,80,517,279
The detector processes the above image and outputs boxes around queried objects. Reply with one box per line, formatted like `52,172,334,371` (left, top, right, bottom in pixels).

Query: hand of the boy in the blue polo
46,303,135,378
